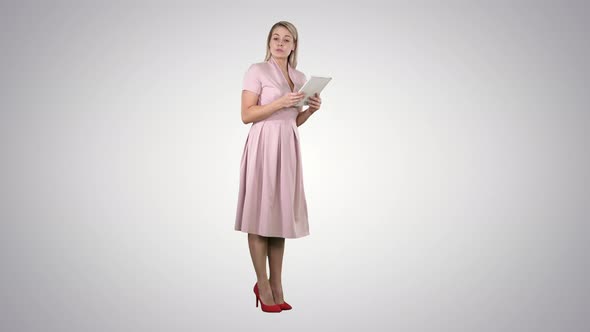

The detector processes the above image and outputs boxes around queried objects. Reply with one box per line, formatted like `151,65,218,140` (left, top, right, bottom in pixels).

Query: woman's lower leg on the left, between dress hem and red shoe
248,233,275,305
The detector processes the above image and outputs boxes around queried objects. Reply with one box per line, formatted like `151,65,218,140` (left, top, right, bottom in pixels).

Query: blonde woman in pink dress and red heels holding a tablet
235,21,321,312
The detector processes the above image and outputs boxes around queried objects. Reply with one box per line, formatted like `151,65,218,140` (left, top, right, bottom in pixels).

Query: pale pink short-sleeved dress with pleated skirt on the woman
235,56,309,238
